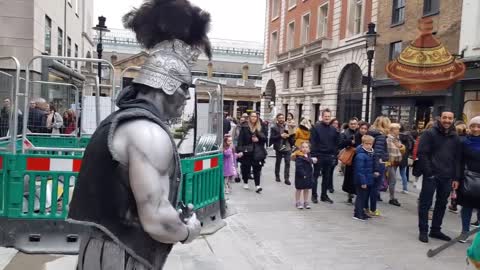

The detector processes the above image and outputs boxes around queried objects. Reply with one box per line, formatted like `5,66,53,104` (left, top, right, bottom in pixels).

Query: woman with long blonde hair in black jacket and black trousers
237,112,267,193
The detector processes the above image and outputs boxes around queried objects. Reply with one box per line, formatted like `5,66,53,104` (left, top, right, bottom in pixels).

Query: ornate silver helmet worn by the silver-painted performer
133,39,201,95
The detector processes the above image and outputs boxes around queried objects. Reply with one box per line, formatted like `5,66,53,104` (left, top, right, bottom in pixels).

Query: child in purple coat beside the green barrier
223,135,243,194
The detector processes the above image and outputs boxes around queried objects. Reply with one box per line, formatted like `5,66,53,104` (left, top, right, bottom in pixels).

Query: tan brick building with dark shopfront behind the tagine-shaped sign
372,0,462,127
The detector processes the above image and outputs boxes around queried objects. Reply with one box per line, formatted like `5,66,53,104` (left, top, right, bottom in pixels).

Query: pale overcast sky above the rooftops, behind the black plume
94,0,265,43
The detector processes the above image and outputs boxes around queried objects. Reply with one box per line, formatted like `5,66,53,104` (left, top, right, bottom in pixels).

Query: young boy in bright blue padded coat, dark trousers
353,135,380,221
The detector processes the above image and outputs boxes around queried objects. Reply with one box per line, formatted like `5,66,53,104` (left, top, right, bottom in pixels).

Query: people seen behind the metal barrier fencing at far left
0,98,77,137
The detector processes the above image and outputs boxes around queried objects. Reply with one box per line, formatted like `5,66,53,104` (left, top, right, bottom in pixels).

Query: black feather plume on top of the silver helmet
123,0,212,58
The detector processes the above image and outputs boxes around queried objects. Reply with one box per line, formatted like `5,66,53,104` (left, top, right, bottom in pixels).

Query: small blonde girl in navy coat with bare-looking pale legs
292,142,317,209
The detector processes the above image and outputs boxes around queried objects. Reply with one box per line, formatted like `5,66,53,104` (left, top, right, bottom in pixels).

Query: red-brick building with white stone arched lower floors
262,0,379,121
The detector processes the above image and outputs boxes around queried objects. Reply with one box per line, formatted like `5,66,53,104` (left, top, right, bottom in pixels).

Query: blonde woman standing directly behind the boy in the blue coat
367,116,391,216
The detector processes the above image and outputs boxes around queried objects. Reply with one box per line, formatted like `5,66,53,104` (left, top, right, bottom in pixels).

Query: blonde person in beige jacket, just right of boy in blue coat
386,123,405,206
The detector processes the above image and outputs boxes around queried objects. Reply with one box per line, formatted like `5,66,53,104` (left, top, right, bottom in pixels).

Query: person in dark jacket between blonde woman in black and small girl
270,113,294,185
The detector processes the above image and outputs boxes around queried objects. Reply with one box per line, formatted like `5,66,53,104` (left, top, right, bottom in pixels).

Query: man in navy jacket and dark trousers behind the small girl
310,109,340,203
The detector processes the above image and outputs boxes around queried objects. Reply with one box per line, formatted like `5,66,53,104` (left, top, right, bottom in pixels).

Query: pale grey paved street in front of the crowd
0,153,467,270
